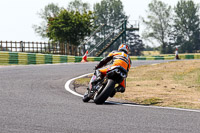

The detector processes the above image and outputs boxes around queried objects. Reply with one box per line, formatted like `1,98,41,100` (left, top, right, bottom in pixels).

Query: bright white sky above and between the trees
0,0,200,45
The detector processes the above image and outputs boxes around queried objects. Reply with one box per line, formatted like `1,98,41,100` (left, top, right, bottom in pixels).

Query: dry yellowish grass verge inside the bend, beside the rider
75,60,200,109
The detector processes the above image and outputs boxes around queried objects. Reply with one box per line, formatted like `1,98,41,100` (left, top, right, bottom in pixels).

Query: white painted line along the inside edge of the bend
65,73,200,113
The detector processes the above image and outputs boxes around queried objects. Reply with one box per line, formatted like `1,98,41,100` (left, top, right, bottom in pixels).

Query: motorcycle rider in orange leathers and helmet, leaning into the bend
94,44,131,97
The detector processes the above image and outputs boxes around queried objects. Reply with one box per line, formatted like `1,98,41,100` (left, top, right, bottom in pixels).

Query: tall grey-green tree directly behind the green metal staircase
91,0,127,53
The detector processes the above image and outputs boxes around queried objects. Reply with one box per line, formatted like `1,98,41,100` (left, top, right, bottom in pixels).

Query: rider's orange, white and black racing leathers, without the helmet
96,51,131,88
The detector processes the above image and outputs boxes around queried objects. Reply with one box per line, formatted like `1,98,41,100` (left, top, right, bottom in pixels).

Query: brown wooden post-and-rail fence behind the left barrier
0,41,82,55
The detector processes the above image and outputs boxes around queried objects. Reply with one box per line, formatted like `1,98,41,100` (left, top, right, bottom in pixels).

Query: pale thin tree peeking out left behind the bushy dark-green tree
33,3,61,38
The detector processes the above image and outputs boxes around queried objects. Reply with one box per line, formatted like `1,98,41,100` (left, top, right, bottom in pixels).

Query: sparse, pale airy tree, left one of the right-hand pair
142,0,172,54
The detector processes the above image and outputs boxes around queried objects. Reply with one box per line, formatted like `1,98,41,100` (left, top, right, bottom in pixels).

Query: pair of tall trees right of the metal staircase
142,0,200,54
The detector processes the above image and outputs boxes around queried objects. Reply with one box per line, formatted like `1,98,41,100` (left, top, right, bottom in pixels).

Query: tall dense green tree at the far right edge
174,0,200,53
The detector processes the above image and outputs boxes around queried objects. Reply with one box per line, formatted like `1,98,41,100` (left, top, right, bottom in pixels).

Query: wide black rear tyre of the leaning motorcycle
94,79,115,104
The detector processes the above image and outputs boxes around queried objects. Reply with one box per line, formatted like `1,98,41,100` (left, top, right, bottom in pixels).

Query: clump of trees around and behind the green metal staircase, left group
33,0,144,53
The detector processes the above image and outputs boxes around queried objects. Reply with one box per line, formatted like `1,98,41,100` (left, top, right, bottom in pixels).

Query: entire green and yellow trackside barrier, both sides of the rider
0,51,200,65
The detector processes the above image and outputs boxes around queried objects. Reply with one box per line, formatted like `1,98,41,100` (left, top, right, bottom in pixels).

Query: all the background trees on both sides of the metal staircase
33,0,200,55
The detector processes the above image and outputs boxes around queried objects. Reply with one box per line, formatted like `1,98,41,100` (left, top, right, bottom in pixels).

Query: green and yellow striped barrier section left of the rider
0,51,102,65
